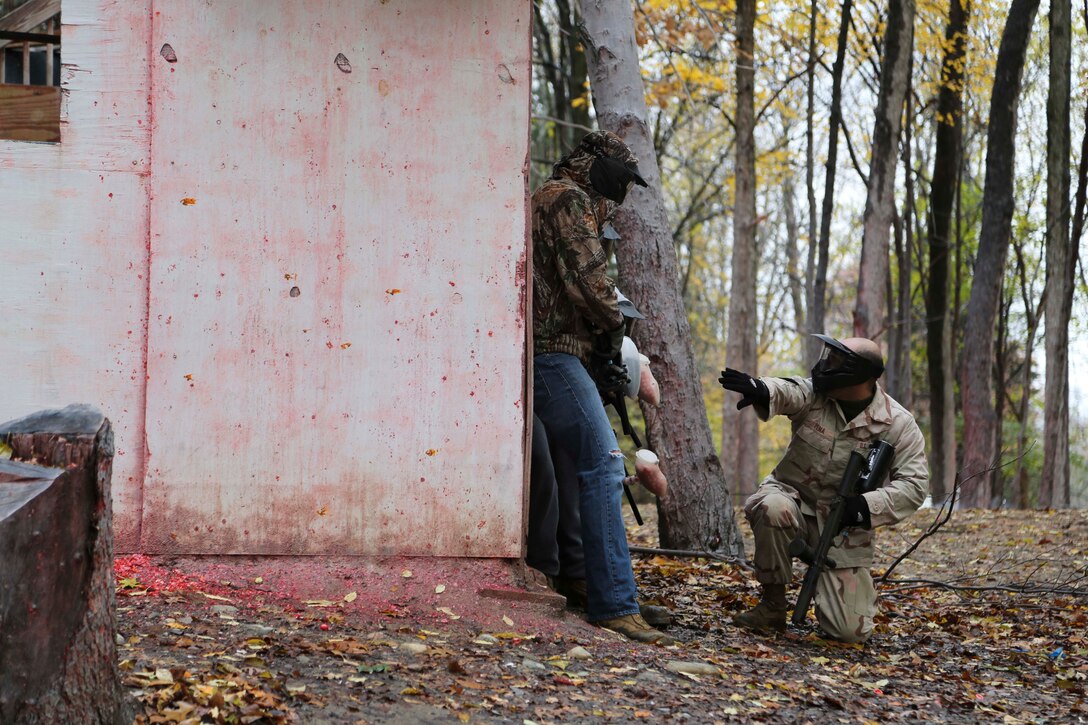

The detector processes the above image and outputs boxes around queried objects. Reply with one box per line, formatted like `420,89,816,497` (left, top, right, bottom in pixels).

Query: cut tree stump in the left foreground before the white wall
0,405,135,723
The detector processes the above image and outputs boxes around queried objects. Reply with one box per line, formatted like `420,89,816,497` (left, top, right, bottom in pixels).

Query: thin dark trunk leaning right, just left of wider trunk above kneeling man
808,0,853,343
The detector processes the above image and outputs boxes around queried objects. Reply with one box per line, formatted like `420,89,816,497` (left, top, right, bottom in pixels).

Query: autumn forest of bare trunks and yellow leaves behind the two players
531,0,1088,551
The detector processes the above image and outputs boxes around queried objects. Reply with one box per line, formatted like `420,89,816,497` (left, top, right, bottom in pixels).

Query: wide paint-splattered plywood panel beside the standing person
143,0,530,556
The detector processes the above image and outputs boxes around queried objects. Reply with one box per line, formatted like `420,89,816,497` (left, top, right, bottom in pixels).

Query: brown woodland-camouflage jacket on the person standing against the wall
532,167,623,364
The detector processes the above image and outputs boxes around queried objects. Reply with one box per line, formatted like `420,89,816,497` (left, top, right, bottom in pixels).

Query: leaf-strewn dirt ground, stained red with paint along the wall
116,507,1088,724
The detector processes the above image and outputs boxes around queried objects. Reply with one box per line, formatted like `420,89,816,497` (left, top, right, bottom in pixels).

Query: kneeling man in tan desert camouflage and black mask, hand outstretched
718,335,929,642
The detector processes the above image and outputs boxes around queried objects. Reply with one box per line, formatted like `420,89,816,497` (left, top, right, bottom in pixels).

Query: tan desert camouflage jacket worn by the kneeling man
755,378,929,567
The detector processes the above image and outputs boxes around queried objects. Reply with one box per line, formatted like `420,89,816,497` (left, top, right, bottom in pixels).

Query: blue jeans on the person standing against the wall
533,353,639,622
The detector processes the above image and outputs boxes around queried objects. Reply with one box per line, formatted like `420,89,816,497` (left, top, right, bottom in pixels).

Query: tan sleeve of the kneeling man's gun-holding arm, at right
865,411,929,528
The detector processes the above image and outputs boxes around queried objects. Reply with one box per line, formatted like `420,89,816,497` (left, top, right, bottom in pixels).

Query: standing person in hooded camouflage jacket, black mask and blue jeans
532,131,675,644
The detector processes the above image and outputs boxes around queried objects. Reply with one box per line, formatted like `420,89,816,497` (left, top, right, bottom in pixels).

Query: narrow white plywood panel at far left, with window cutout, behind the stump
0,0,151,551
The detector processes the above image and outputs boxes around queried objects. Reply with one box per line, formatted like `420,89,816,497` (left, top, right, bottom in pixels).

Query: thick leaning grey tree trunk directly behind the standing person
581,0,744,556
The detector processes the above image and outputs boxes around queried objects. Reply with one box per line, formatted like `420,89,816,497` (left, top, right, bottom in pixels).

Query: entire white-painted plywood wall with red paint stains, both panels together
0,0,530,556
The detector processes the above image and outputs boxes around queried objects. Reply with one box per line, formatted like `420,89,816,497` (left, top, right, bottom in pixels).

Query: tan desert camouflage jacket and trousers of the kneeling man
744,378,929,642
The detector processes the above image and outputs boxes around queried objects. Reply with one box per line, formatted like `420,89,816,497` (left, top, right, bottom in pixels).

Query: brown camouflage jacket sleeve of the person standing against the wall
554,189,623,330
